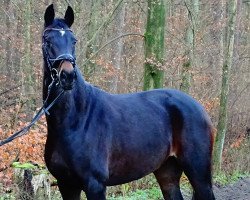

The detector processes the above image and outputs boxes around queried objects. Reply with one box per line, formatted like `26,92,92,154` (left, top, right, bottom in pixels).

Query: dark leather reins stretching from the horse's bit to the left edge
0,79,64,146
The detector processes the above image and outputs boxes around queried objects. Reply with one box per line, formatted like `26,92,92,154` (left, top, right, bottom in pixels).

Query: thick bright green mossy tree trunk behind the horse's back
143,0,166,90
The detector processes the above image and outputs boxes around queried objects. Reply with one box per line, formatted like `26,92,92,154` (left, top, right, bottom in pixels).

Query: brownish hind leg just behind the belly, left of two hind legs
154,157,183,200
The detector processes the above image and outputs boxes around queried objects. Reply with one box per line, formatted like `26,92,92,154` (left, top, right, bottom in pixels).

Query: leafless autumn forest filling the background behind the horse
0,0,250,198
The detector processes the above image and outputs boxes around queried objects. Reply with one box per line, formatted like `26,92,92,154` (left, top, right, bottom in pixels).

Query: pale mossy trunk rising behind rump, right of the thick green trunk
180,0,199,93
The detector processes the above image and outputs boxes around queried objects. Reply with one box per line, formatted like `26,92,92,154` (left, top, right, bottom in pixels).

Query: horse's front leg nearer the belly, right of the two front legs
85,178,106,200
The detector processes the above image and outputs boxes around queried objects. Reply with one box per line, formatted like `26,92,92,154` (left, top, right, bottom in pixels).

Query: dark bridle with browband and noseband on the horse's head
42,28,76,80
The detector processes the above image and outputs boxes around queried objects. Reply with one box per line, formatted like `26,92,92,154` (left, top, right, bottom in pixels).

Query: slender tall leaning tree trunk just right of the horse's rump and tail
213,0,237,172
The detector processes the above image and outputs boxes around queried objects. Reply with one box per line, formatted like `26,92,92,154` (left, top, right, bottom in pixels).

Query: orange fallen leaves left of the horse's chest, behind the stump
0,118,47,184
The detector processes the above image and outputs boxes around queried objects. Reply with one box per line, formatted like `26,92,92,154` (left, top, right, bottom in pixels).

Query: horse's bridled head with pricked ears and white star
42,4,76,90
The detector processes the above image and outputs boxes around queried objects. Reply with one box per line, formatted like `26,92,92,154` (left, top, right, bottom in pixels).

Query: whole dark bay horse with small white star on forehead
43,5,214,200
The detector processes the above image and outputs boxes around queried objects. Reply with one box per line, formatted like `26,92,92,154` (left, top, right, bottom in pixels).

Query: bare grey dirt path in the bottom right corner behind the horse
214,177,250,200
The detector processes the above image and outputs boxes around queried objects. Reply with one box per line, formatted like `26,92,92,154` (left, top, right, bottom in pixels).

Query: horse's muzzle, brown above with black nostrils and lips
59,60,76,90
